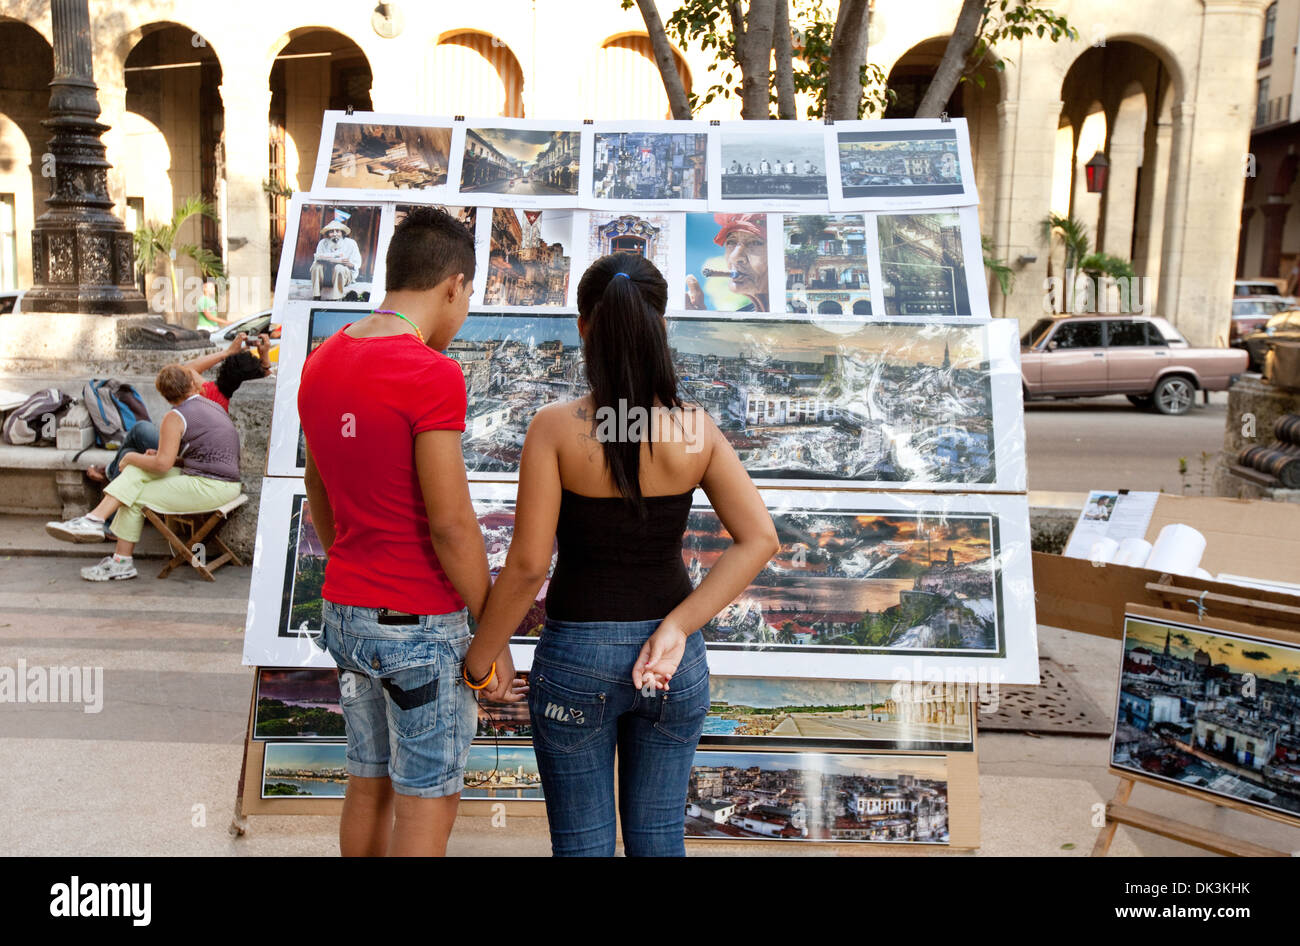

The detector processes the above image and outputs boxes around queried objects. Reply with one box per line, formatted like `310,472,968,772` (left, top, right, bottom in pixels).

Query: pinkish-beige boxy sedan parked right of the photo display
1021,316,1248,415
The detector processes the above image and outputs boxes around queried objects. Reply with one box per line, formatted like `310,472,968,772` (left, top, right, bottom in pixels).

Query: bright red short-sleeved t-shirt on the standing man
298,329,465,615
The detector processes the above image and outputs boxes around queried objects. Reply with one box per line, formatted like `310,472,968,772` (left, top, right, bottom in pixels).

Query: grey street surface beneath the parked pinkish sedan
1024,392,1227,495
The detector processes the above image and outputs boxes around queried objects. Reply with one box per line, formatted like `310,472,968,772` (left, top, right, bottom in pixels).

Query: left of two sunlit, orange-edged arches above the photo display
428,31,524,118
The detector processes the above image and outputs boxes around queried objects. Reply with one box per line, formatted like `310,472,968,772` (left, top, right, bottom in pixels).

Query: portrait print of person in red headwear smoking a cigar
686,213,771,312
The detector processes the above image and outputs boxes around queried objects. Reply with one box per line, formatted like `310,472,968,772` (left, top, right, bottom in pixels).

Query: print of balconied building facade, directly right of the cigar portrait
783,213,875,316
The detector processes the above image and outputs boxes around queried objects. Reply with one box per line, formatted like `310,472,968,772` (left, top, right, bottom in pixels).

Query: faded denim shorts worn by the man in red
320,600,478,798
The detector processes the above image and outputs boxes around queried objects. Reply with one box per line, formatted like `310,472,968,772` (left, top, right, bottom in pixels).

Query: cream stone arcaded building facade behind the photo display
0,0,1268,343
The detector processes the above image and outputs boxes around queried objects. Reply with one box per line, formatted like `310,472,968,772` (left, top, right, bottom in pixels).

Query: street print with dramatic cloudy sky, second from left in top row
459,122,581,207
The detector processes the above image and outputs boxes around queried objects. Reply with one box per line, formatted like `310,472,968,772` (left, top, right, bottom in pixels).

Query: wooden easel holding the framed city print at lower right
1092,605,1300,858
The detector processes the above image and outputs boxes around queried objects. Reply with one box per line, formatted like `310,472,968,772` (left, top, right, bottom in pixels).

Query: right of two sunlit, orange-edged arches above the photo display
582,32,690,118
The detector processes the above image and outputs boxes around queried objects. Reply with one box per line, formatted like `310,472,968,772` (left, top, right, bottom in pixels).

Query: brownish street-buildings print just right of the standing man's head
484,207,573,308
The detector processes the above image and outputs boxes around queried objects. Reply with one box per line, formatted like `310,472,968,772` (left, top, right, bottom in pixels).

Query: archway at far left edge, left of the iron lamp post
0,19,55,288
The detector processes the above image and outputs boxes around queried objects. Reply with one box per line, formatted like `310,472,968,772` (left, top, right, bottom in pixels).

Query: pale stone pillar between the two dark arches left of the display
221,79,277,312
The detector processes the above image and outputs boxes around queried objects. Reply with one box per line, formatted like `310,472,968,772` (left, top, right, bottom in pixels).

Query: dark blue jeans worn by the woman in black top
528,620,709,858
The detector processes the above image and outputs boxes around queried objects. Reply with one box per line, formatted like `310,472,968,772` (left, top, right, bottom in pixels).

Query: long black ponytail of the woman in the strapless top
577,253,683,509
